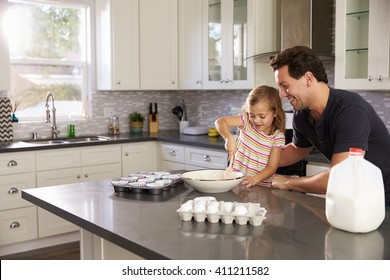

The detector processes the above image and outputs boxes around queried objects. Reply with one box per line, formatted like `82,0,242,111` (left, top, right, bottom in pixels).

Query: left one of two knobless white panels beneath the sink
36,149,81,171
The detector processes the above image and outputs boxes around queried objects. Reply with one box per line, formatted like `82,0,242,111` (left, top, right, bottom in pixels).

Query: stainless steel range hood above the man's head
247,0,334,62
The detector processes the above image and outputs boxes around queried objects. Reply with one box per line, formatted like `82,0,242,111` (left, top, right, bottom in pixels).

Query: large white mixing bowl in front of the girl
181,169,244,193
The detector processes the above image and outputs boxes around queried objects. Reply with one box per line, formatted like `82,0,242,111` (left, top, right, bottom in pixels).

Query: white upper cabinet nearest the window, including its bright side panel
95,0,140,90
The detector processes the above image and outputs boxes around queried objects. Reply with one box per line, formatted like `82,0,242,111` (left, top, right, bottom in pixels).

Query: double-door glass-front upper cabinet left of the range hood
203,0,254,89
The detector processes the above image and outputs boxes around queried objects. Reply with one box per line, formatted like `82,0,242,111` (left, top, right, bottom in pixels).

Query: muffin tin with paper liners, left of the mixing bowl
110,172,181,194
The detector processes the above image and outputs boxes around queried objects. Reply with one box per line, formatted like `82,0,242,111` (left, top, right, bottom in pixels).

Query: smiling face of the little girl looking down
248,100,276,135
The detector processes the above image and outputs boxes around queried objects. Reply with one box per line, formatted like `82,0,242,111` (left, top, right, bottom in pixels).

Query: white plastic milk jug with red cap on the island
325,148,385,233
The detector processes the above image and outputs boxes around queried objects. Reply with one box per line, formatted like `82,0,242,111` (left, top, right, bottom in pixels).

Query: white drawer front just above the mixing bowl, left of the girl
185,147,228,169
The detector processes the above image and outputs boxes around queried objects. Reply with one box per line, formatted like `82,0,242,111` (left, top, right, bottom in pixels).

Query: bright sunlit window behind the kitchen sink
5,0,91,121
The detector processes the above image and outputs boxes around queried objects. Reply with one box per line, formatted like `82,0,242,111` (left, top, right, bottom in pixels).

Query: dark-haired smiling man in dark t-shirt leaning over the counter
271,46,390,205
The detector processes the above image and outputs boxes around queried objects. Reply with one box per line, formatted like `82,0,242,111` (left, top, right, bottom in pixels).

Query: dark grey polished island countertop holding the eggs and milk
22,180,390,260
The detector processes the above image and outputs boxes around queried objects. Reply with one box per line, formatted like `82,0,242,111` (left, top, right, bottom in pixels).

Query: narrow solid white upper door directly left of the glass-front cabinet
179,0,203,89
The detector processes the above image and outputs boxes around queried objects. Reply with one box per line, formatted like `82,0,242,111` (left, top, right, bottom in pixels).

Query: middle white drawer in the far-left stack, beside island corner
0,172,36,210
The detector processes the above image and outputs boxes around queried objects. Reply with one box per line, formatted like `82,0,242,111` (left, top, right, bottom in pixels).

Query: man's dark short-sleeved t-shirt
293,88,390,203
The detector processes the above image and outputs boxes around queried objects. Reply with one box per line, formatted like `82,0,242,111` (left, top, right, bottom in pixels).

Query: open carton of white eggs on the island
177,197,267,226
